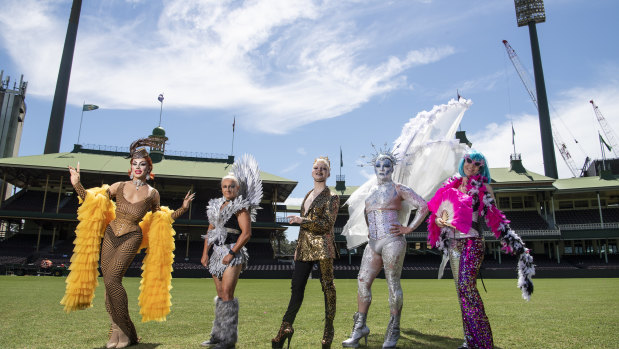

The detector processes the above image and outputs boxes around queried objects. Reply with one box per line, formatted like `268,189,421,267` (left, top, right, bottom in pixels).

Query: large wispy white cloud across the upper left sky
0,0,454,133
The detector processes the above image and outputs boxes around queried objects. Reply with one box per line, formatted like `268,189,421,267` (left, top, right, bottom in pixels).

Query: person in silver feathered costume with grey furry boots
201,154,262,348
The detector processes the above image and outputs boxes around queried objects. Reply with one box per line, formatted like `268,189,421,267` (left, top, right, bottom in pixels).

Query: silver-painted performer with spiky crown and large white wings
342,99,471,348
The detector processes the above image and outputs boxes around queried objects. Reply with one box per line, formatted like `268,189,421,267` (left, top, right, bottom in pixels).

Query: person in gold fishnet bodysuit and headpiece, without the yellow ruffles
69,141,195,348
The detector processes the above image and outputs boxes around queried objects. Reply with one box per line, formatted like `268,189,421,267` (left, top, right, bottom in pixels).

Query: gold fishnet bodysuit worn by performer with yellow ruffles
75,182,185,343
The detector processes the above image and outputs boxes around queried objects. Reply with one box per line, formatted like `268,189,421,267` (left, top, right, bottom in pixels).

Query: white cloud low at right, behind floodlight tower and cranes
469,82,619,178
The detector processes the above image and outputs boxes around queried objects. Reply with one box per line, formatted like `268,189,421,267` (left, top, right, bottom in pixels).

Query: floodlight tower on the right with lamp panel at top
514,0,559,178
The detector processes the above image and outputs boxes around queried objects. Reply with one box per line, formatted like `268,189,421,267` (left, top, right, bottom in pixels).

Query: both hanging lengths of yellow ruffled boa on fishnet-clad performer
60,185,176,322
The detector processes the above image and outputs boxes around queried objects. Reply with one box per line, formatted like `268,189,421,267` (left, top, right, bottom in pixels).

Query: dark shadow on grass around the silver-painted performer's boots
359,329,500,349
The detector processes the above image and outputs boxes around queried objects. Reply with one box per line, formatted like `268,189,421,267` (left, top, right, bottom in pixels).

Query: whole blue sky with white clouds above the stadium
0,0,619,234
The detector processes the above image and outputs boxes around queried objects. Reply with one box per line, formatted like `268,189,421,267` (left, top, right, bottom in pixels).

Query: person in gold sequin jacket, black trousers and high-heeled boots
271,157,340,348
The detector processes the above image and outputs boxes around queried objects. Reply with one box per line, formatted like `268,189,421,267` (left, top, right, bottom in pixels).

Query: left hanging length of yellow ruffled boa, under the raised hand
60,185,116,313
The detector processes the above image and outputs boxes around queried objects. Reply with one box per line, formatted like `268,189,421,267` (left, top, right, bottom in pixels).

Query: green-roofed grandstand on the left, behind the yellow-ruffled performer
0,127,297,277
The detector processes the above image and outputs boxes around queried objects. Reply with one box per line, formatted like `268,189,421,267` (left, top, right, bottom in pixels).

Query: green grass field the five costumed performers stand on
0,276,619,349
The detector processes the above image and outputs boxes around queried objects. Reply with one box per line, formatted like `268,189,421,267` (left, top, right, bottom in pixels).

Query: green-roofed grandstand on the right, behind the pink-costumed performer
320,150,619,278
